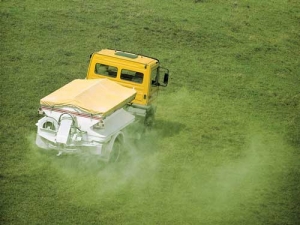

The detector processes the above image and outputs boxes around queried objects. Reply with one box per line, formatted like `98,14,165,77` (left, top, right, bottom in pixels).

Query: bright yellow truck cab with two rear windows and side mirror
86,49,169,108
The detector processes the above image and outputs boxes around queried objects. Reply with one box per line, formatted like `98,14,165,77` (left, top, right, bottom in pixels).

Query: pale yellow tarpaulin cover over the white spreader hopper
40,78,136,116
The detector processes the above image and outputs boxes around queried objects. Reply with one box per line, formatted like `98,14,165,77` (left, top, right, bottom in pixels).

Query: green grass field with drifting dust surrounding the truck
0,0,300,225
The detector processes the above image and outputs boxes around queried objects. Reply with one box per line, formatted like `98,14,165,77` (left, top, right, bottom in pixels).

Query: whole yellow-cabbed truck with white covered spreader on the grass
36,49,169,162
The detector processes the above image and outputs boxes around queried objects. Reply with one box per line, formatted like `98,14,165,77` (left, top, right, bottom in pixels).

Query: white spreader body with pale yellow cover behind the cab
36,79,136,159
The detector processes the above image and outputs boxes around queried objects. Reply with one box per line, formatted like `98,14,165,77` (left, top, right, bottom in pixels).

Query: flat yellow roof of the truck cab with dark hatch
96,49,159,65
